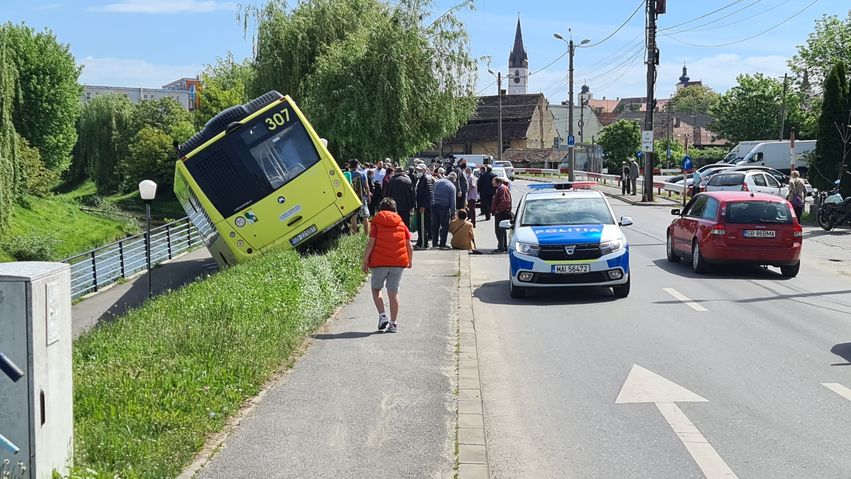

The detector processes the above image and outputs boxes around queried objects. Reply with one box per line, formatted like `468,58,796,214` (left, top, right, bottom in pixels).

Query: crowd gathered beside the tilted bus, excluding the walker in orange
344,157,511,254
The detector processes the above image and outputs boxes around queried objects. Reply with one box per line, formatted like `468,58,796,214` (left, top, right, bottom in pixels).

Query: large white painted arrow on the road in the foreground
615,364,737,479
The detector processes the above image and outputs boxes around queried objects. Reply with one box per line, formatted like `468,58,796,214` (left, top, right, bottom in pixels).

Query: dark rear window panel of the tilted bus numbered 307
185,103,319,218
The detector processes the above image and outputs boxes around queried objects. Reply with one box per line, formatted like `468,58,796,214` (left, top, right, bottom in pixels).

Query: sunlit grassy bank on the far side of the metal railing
0,182,186,262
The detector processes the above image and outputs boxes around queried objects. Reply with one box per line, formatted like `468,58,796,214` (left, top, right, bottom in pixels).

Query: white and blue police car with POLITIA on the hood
499,182,632,298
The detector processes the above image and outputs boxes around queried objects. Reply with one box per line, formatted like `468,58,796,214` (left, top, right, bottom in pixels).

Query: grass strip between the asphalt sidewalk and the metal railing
74,235,365,478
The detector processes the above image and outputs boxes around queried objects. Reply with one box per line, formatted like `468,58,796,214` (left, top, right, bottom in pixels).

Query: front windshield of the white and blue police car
520,197,615,226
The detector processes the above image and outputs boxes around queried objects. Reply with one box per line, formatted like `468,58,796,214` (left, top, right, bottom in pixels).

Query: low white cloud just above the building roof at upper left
80,57,204,88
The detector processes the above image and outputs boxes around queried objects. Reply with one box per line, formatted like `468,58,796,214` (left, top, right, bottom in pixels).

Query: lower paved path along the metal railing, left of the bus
71,248,217,338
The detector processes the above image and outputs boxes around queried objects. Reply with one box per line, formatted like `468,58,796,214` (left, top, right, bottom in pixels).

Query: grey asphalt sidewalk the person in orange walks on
191,250,459,479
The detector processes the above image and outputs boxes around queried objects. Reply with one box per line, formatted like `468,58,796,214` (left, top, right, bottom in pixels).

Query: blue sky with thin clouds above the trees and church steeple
0,0,851,103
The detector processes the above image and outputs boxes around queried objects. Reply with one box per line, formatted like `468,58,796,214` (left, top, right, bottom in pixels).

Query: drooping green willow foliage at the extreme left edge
0,28,21,232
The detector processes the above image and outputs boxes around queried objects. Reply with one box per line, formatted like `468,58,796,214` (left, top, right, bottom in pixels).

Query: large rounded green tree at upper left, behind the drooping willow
2,23,82,173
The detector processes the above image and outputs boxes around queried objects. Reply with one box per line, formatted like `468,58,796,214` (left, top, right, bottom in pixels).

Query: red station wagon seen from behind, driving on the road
667,191,803,278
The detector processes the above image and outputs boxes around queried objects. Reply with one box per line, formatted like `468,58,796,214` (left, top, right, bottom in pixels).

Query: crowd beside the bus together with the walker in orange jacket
358,158,511,333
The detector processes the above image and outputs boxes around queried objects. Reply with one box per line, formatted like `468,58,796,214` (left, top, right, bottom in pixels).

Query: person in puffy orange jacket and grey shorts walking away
361,198,414,333
